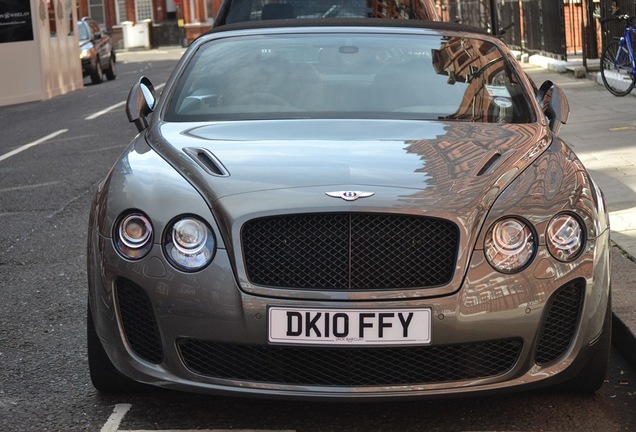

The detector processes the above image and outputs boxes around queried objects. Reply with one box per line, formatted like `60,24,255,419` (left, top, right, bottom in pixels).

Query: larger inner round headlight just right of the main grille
484,218,536,273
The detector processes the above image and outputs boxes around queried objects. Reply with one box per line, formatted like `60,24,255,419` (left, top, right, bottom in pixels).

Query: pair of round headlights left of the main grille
114,212,216,272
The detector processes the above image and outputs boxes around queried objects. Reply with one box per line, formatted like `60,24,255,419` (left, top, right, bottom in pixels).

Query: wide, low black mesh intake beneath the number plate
177,339,522,386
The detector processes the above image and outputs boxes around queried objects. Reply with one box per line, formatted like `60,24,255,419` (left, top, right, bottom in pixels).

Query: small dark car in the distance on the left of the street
77,18,117,84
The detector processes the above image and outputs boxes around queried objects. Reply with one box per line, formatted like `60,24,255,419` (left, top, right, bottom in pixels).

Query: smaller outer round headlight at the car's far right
545,214,584,262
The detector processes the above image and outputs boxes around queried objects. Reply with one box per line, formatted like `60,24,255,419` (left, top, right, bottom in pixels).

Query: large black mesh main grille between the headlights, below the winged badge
242,213,459,290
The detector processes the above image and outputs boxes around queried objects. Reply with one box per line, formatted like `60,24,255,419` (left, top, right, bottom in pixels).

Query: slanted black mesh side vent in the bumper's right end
536,279,585,365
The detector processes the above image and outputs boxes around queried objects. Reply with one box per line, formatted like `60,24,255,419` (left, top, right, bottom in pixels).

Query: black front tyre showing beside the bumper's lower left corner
86,306,137,393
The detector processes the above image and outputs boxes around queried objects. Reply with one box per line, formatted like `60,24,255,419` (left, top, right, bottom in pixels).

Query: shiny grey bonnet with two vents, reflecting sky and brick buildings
148,120,547,212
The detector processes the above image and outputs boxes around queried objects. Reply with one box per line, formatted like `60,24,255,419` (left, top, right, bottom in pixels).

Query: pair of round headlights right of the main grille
484,213,585,273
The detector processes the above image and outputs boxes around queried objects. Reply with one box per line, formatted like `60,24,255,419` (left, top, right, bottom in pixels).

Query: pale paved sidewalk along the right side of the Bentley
522,56,636,366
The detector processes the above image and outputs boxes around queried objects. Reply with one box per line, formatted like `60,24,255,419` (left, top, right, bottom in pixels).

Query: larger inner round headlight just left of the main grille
164,217,216,271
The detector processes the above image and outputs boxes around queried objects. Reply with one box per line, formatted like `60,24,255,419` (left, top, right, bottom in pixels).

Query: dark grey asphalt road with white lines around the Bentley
0,50,636,432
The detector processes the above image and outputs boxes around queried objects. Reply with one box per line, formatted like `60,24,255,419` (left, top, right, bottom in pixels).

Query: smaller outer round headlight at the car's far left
115,213,152,259
